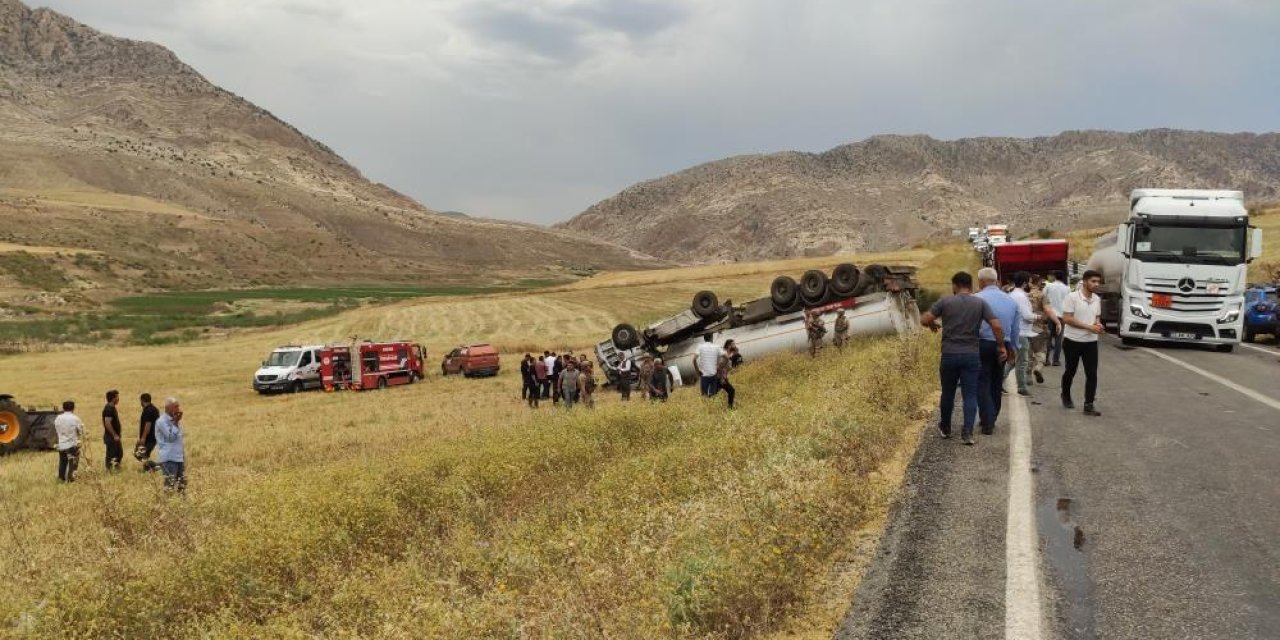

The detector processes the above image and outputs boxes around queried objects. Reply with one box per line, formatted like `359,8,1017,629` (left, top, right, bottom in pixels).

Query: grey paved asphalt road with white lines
837,338,1280,640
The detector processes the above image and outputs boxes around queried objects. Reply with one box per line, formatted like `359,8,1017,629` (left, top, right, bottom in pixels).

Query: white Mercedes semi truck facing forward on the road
1088,189,1262,352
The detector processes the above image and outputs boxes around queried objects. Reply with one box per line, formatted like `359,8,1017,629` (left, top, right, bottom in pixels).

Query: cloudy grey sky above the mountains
33,0,1280,224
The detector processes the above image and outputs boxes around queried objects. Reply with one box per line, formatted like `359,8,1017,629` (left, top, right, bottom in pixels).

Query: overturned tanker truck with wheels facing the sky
595,264,920,384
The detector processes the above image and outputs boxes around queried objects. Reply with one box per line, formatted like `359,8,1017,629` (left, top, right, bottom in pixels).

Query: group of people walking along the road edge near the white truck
920,268,1105,444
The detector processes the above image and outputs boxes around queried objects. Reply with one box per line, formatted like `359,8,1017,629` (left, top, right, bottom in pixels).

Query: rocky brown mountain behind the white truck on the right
562,129,1280,262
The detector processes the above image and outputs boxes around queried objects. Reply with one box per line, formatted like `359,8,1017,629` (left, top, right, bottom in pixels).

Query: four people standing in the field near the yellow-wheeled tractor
54,389,187,492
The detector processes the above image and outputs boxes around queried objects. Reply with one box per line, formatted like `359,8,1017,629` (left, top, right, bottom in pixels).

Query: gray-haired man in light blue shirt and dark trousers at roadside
978,268,1021,435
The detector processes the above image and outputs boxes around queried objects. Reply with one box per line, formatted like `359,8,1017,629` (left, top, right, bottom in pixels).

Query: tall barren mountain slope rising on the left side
0,0,657,296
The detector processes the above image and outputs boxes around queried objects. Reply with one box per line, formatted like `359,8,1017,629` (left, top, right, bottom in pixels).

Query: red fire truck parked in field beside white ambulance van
320,340,426,392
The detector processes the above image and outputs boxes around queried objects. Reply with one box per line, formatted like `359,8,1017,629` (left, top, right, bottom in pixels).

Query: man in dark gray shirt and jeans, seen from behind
920,271,1005,444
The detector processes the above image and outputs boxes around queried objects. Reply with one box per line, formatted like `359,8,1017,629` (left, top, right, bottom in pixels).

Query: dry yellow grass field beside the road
0,248,969,637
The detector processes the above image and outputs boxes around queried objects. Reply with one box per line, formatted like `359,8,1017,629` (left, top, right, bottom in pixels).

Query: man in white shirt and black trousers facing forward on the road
1062,270,1103,417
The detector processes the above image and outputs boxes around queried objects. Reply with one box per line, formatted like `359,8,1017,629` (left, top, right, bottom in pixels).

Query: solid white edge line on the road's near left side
1005,378,1043,640
